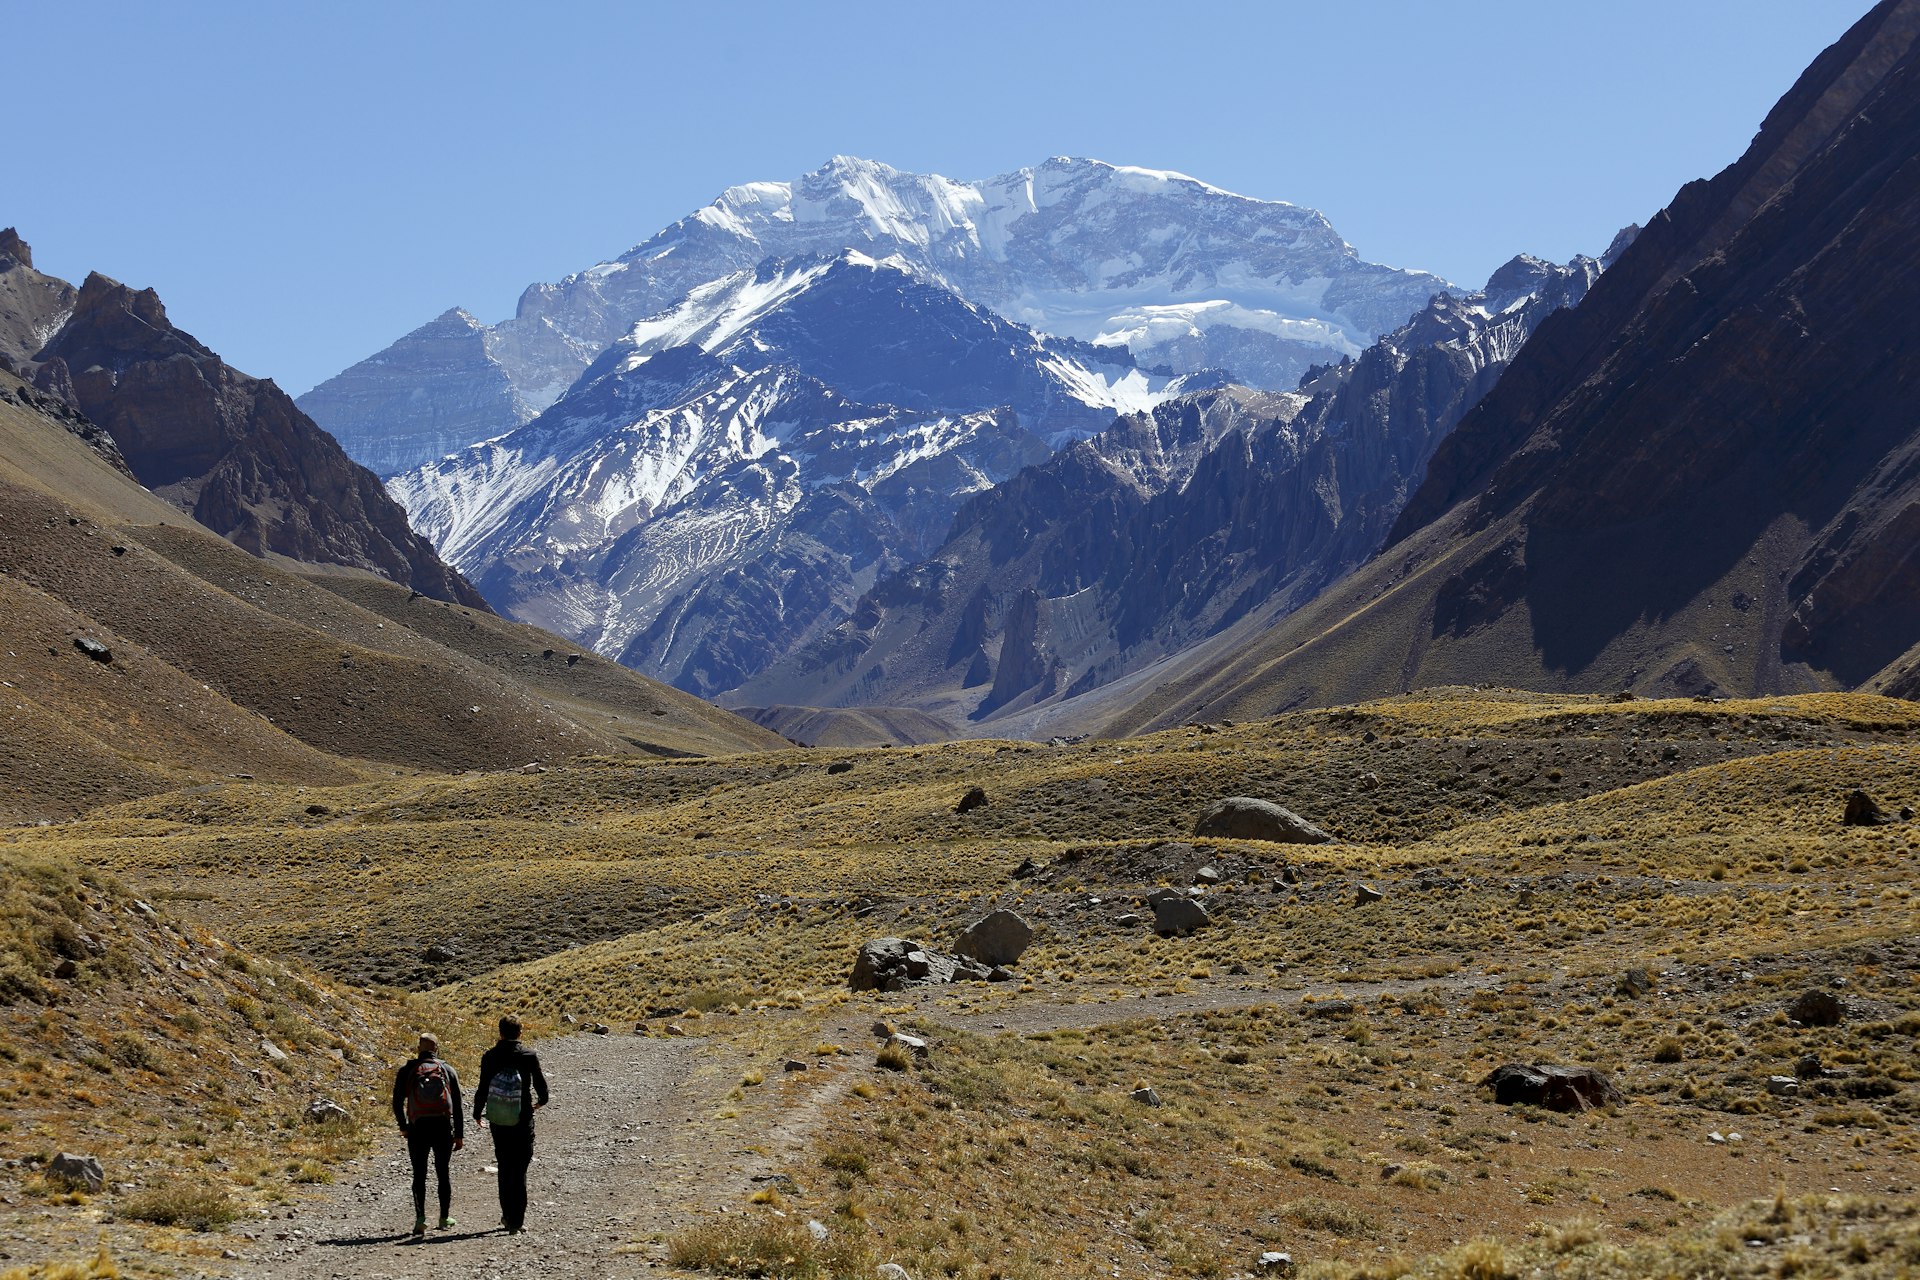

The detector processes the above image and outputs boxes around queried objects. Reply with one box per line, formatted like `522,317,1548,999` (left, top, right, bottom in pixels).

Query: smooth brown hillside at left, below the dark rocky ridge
0,374,778,821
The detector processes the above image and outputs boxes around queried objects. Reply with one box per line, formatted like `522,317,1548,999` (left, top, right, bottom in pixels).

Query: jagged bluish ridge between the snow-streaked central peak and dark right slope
730,257,1601,723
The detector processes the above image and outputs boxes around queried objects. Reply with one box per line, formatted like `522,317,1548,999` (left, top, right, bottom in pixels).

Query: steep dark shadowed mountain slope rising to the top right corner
1116,0,1920,727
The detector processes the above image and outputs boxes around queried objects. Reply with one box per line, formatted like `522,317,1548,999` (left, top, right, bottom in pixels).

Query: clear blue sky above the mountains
0,0,1868,391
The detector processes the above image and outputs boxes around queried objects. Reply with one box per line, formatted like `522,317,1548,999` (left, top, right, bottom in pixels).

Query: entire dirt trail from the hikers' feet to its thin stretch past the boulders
234,973,1509,1280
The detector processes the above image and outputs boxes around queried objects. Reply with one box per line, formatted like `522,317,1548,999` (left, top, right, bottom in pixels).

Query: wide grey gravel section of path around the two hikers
234,1034,708,1280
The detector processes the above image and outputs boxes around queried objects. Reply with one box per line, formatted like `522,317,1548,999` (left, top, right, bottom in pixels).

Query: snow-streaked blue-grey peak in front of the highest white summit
392,251,1205,695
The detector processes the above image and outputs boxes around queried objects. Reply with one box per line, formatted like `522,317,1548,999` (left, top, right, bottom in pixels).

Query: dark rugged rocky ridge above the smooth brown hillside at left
0,234,486,608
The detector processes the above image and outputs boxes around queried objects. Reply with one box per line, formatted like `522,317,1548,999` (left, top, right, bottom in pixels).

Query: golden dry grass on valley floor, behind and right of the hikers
15,691,1920,1278
